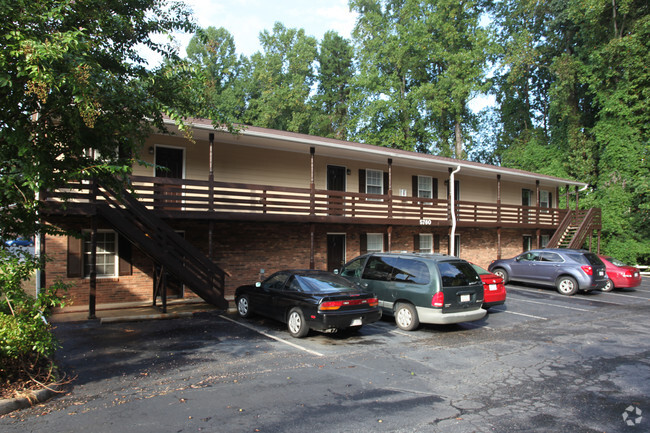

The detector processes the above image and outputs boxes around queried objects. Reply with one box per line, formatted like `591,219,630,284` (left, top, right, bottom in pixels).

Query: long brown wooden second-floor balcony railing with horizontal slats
46,176,567,229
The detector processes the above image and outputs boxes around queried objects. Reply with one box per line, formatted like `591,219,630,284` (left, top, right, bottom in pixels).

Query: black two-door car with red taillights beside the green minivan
235,270,381,338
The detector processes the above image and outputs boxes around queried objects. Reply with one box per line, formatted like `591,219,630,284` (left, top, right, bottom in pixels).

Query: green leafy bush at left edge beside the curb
0,248,67,384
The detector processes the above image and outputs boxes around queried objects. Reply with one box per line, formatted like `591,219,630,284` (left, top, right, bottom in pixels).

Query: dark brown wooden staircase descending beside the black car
94,181,228,309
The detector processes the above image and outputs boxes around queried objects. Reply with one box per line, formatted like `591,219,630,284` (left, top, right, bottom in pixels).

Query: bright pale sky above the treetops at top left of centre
179,0,357,57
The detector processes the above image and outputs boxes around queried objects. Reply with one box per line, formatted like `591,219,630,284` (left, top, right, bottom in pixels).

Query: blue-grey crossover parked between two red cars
488,248,607,296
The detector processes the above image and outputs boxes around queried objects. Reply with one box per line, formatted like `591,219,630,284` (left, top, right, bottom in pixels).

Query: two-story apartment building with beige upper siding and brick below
43,120,600,314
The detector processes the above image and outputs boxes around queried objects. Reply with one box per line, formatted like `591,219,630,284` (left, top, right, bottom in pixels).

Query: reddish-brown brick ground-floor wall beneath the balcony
46,221,552,305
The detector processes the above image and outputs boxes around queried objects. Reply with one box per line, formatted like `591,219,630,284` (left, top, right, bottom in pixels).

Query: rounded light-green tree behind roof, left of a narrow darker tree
244,23,317,133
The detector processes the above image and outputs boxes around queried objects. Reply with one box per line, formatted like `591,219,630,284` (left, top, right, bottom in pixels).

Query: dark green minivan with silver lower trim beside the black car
340,253,485,331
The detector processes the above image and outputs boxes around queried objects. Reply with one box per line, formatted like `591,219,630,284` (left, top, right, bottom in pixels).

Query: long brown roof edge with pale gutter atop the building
166,118,587,188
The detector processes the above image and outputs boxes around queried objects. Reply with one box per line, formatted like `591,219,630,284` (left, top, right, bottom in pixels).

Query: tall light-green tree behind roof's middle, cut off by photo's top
350,0,492,158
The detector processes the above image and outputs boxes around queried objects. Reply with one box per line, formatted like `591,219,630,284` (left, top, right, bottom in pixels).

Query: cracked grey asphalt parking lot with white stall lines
0,277,650,433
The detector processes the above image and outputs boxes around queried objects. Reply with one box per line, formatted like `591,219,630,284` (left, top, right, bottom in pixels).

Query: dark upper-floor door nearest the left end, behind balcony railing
155,146,184,210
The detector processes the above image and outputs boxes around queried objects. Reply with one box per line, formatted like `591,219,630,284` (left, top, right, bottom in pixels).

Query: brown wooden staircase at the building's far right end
547,208,601,249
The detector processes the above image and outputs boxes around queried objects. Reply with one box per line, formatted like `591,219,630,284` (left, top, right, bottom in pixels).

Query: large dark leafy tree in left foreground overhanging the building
0,0,203,384
